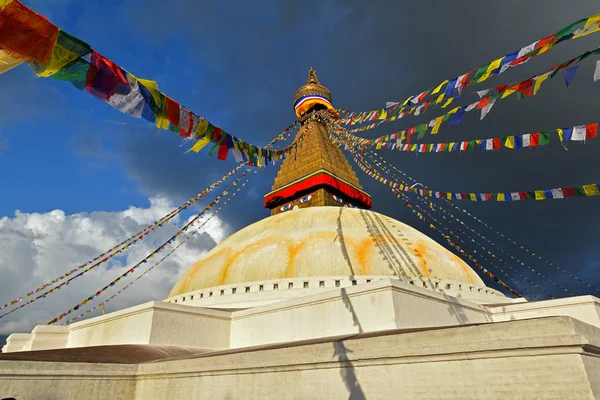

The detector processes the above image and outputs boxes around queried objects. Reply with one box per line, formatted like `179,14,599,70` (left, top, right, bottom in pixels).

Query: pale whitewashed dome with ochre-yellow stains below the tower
169,207,485,297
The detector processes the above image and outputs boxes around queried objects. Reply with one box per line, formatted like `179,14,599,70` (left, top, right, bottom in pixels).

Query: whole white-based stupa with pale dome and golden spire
0,69,600,400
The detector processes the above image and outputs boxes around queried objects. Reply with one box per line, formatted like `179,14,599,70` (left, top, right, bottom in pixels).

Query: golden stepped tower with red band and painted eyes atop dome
265,68,371,215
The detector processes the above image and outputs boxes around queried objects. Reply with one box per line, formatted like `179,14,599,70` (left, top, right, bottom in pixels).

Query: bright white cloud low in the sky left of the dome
0,197,227,334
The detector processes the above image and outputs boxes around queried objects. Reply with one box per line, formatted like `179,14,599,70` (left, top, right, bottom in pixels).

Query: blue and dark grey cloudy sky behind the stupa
0,0,600,340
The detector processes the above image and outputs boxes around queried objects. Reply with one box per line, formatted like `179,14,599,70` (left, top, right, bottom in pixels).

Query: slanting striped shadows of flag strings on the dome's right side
360,210,421,276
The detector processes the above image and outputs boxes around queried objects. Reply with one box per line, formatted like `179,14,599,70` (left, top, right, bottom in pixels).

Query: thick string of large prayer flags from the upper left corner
0,0,296,166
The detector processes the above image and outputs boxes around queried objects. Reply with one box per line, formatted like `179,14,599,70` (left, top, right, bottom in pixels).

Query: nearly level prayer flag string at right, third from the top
341,122,598,153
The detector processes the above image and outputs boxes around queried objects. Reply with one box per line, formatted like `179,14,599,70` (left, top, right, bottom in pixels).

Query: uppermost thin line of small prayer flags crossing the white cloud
0,165,244,318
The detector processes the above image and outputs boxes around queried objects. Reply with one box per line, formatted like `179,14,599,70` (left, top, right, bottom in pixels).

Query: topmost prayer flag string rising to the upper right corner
342,14,600,122
